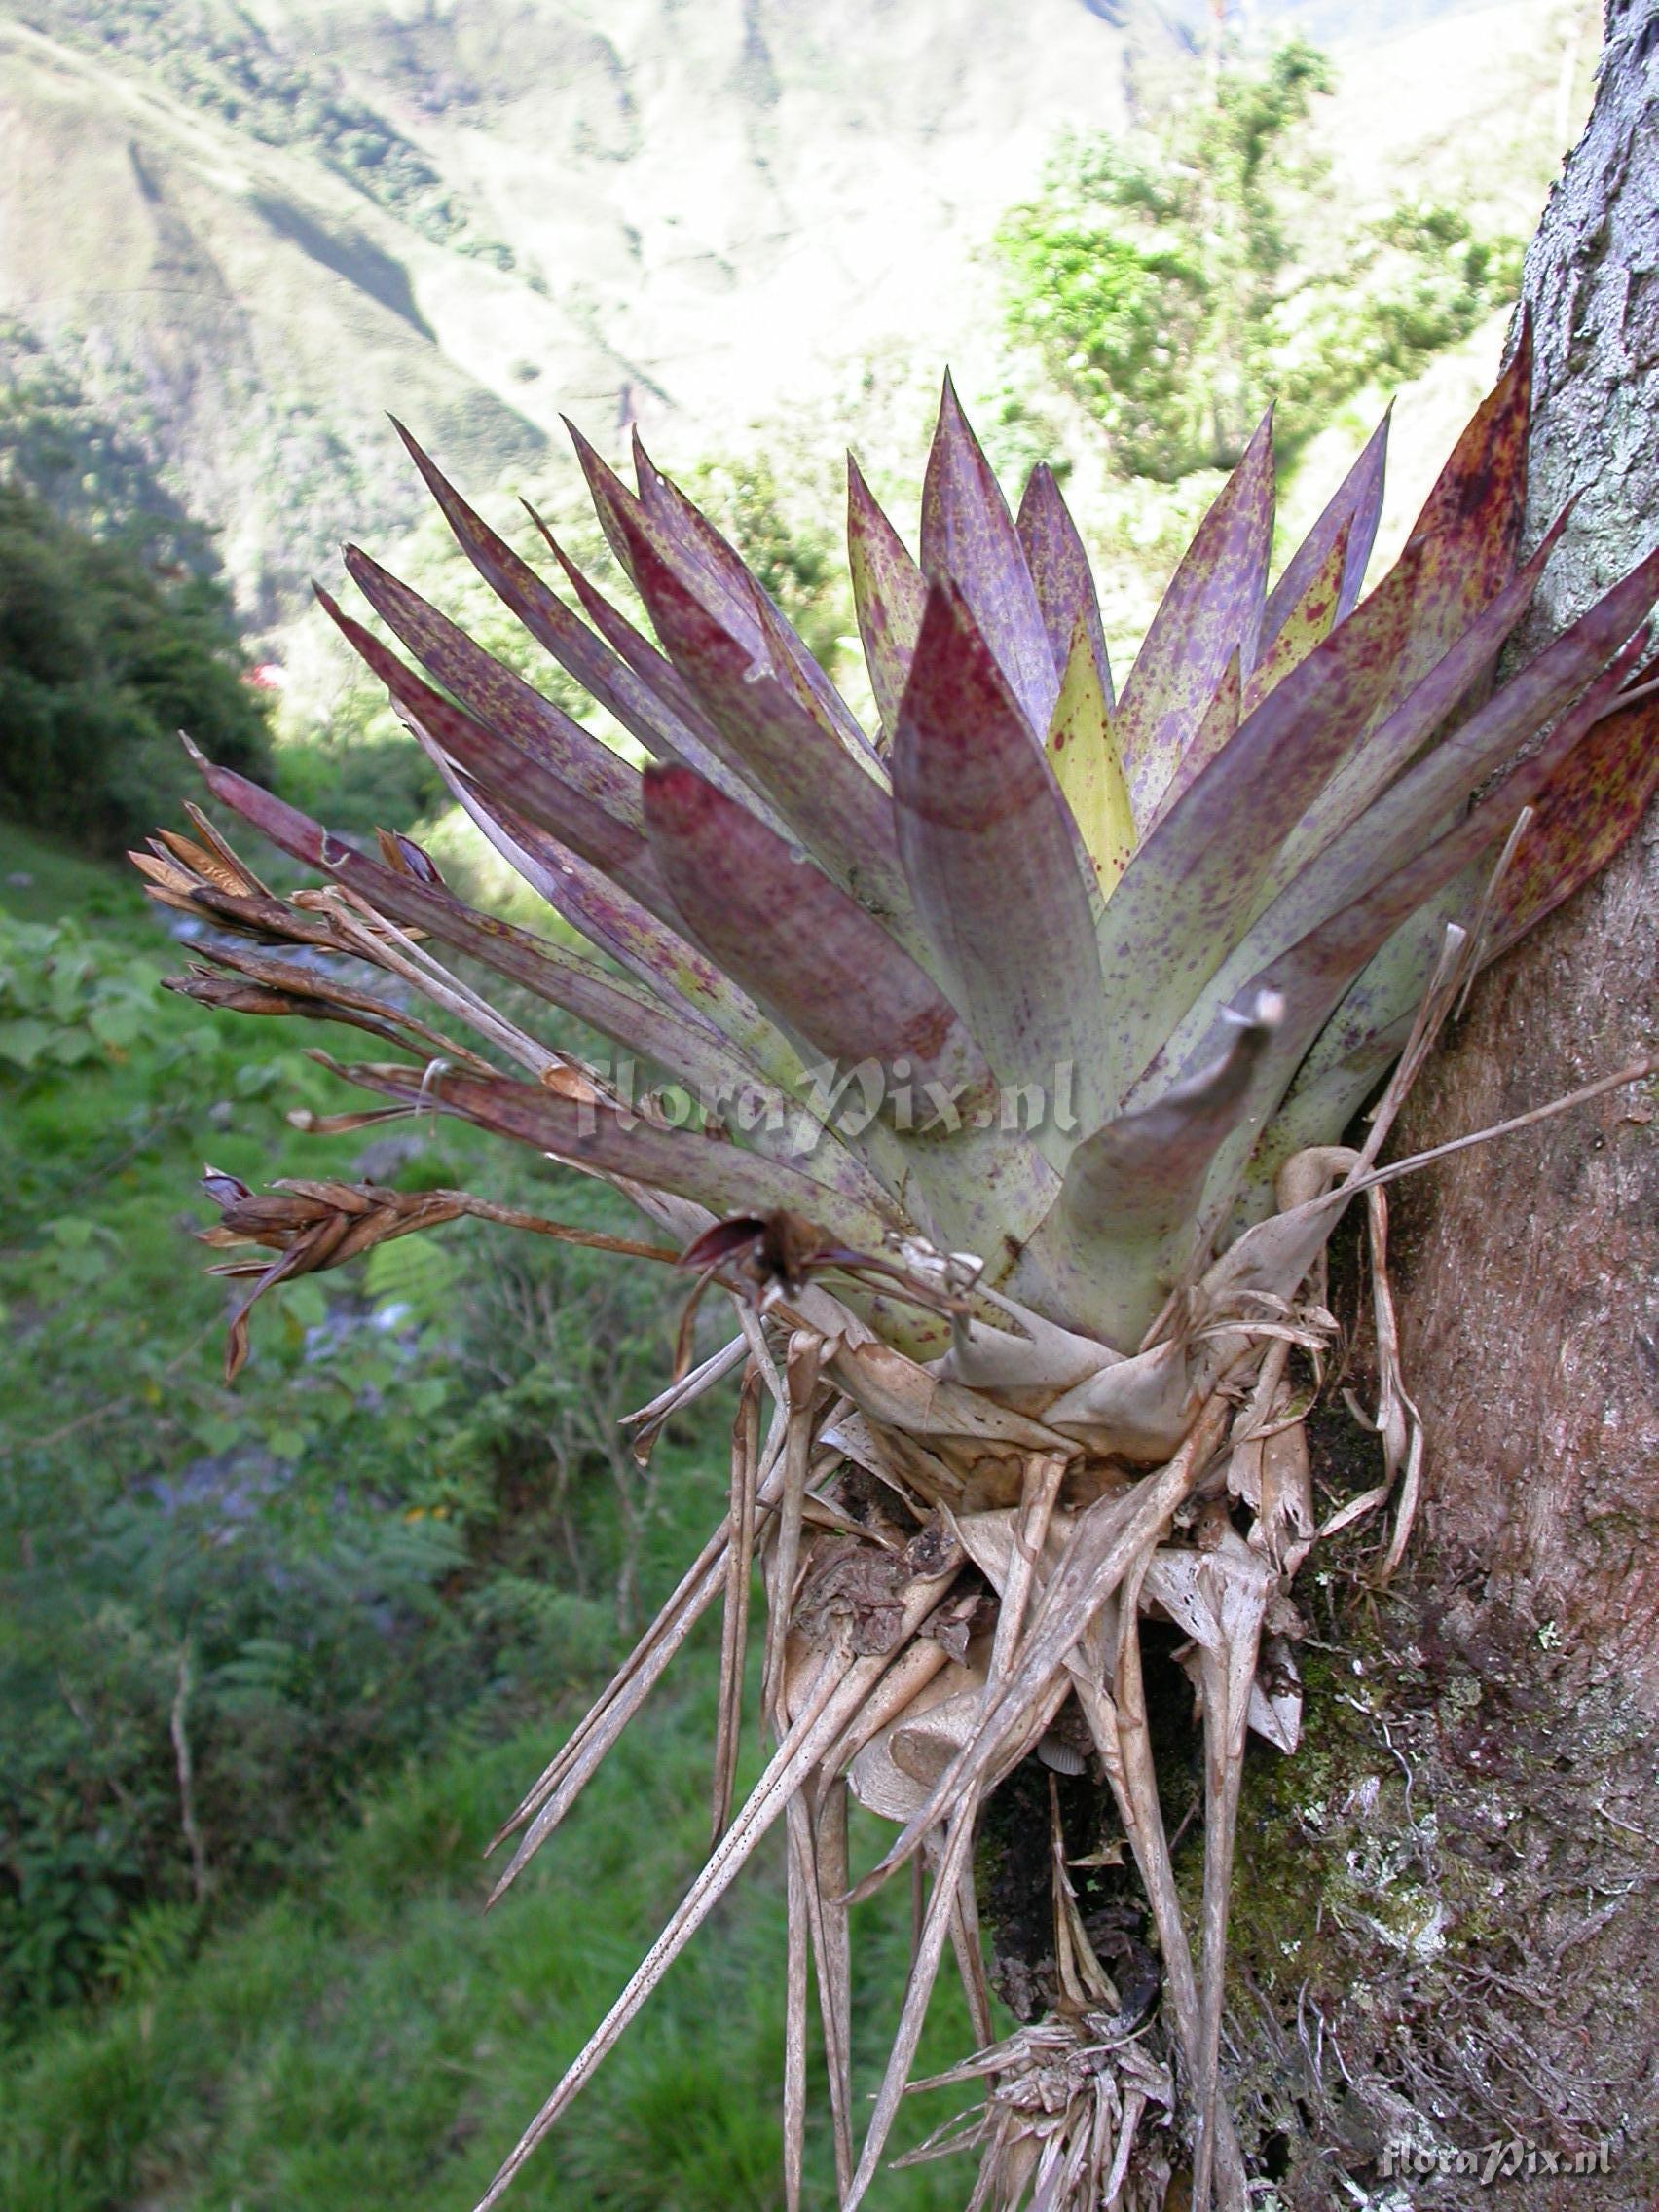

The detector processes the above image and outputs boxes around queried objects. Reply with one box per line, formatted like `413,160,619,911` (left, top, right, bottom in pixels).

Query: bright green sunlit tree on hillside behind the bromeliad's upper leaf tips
998,40,1520,482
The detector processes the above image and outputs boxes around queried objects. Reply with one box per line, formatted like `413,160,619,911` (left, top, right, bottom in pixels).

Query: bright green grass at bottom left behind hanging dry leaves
0,1657,986,2212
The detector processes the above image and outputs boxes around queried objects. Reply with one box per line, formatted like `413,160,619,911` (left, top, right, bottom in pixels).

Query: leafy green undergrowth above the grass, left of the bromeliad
0,893,713,2026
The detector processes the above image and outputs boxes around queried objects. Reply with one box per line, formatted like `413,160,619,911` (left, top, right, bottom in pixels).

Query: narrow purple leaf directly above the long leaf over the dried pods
316,588,670,913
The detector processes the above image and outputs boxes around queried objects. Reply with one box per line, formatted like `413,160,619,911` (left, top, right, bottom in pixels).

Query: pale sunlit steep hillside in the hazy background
0,0,1595,624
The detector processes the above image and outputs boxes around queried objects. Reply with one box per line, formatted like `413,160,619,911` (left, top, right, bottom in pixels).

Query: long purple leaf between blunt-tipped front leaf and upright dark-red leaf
614,506,924,932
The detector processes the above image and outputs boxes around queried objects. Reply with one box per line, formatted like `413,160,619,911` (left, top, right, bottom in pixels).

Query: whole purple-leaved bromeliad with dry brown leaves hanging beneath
137,343,1659,2212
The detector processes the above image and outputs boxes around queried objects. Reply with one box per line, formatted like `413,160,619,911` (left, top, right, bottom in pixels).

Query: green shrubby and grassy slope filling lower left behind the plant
0,830,981,2212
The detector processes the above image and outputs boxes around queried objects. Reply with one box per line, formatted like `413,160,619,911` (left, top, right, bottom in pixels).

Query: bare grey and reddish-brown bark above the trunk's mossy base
1398,0,1659,1710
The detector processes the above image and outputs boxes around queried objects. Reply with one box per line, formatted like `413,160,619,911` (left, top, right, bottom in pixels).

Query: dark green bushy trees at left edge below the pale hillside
0,485,268,852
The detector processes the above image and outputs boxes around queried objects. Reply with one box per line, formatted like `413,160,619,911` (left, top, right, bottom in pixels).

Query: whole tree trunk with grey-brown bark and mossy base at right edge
1230,0,1659,2212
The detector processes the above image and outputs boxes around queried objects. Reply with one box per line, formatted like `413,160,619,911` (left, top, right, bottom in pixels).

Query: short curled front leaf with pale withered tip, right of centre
1014,993,1280,1351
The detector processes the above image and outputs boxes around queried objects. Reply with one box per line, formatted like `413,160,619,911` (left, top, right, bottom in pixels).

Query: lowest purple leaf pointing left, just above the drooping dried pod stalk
341,1057,911,1250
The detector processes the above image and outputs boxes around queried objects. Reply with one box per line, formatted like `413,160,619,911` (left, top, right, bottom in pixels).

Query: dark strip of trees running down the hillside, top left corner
24,0,515,270
